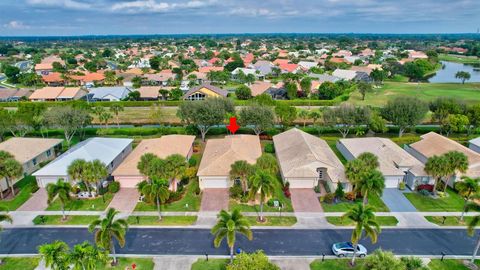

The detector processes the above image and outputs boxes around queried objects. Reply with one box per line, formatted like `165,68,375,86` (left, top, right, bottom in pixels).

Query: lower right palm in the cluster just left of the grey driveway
354,170,385,206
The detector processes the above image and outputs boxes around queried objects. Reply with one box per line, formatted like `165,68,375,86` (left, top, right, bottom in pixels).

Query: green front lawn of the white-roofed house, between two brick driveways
47,193,113,211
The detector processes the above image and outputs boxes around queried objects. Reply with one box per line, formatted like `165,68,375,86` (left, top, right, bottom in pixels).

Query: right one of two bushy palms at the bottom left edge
68,241,108,270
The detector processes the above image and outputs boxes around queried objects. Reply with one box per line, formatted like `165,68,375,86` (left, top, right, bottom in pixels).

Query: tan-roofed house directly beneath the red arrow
197,135,262,190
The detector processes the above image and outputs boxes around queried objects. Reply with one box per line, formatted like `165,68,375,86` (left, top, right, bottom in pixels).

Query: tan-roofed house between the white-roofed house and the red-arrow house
112,135,195,191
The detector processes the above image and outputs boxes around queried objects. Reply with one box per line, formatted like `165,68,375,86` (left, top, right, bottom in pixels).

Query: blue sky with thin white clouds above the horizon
0,0,480,36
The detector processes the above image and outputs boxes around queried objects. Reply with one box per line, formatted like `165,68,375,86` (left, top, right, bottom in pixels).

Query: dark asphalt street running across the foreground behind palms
0,228,478,256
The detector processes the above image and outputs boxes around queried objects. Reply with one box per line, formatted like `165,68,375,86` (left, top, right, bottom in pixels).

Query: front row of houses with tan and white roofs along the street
0,128,480,197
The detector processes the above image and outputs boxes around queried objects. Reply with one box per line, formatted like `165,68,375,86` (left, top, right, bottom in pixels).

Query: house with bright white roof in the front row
33,137,133,187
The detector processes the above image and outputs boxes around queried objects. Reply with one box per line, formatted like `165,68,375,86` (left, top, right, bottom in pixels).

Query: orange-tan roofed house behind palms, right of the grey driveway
405,132,480,181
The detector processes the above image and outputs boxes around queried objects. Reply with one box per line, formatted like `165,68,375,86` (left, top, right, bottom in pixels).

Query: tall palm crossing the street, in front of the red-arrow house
211,209,253,263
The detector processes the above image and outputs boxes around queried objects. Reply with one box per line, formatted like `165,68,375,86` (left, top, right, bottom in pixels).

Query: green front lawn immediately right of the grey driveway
405,189,464,212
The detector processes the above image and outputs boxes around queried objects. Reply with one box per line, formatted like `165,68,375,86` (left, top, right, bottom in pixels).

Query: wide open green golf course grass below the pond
349,81,480,107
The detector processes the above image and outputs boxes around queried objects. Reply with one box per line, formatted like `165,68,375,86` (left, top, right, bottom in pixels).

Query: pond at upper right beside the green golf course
428,61,480,83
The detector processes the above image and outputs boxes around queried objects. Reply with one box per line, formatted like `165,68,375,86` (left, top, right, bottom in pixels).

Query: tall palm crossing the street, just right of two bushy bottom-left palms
88,208,128,264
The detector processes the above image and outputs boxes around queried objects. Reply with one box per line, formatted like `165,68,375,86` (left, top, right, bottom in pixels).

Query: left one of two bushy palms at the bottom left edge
38,241,70,270
